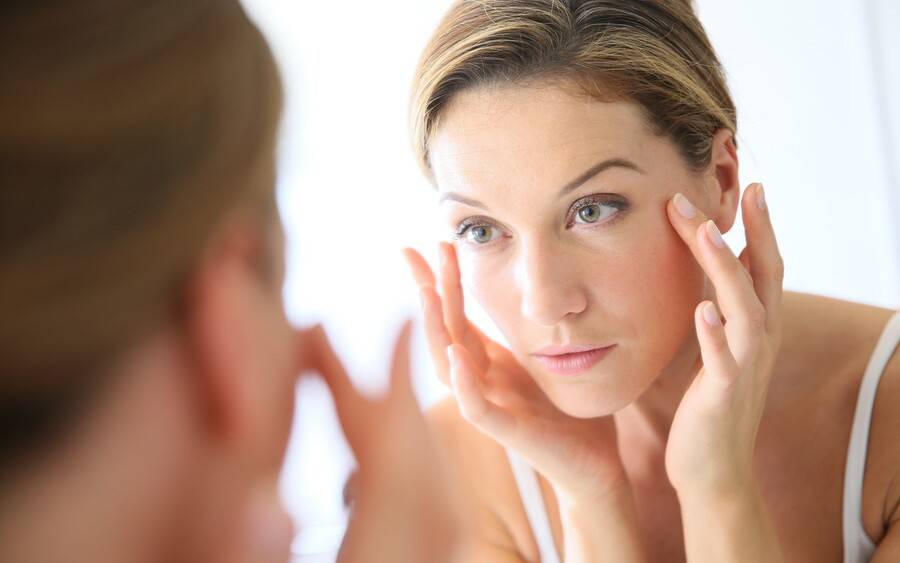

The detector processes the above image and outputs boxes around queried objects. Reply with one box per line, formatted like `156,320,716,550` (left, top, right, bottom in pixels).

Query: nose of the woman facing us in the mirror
516,241,588,326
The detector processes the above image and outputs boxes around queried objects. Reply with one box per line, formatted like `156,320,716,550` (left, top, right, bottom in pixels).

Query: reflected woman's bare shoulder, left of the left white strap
426,397,537,561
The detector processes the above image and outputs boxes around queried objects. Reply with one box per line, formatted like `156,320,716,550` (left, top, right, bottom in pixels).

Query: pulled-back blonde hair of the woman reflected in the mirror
410,0,737,181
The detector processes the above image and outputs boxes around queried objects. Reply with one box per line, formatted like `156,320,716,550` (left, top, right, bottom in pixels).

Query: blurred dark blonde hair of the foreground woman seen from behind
0,0,281,466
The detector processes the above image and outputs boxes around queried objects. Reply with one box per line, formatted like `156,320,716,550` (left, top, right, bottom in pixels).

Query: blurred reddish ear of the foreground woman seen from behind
183,222,262,450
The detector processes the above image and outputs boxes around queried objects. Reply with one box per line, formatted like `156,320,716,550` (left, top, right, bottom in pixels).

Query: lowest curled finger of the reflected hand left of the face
448,344,516,445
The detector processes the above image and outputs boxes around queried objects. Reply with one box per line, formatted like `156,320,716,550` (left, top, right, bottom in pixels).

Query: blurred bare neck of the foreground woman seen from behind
0,334,216,563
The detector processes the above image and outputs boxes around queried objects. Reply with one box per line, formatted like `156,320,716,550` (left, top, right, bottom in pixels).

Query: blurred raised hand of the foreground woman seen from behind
302,323,460,563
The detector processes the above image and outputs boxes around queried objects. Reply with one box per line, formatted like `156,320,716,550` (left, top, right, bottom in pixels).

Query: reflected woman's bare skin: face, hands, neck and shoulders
407,83,900,561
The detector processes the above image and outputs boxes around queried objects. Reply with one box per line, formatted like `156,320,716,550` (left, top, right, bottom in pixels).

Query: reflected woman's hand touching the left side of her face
404,242,629,502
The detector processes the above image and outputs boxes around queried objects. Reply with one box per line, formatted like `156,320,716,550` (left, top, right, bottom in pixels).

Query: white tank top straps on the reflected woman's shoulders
506,312,900,563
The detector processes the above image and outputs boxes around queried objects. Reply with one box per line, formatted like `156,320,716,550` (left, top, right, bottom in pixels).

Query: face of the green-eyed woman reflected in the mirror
430,85,709,417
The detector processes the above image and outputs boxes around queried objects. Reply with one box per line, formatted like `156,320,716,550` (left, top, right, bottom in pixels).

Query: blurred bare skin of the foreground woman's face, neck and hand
0,202,457,563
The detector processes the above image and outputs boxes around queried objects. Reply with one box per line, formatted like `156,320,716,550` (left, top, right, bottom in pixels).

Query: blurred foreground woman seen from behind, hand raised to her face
0,0,454,562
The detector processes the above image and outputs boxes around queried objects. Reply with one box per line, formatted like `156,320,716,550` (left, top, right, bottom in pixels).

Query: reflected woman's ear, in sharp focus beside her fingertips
705,129,741,233
